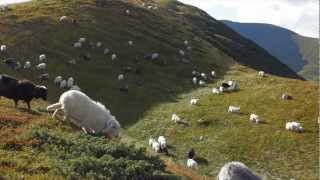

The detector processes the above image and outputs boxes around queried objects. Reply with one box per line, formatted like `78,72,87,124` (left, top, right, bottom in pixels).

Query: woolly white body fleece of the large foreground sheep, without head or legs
60,90,115,133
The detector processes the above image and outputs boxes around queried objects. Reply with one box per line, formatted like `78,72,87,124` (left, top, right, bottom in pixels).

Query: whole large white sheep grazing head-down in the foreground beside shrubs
47,90,120,138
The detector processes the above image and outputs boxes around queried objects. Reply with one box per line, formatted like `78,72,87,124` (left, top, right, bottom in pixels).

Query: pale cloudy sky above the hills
180,0,319,37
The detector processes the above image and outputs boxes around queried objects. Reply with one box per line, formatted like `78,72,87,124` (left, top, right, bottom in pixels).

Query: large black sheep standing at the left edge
0,74,48,109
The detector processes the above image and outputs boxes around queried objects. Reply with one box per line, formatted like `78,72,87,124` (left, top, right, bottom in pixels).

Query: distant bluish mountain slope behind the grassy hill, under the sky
223,21,319,80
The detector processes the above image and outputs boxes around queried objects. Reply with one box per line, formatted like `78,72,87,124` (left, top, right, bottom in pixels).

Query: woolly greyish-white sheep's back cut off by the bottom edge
217,162,261,180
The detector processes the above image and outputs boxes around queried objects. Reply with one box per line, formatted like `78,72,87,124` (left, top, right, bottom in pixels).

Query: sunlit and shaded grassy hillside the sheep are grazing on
0,0,319,179
